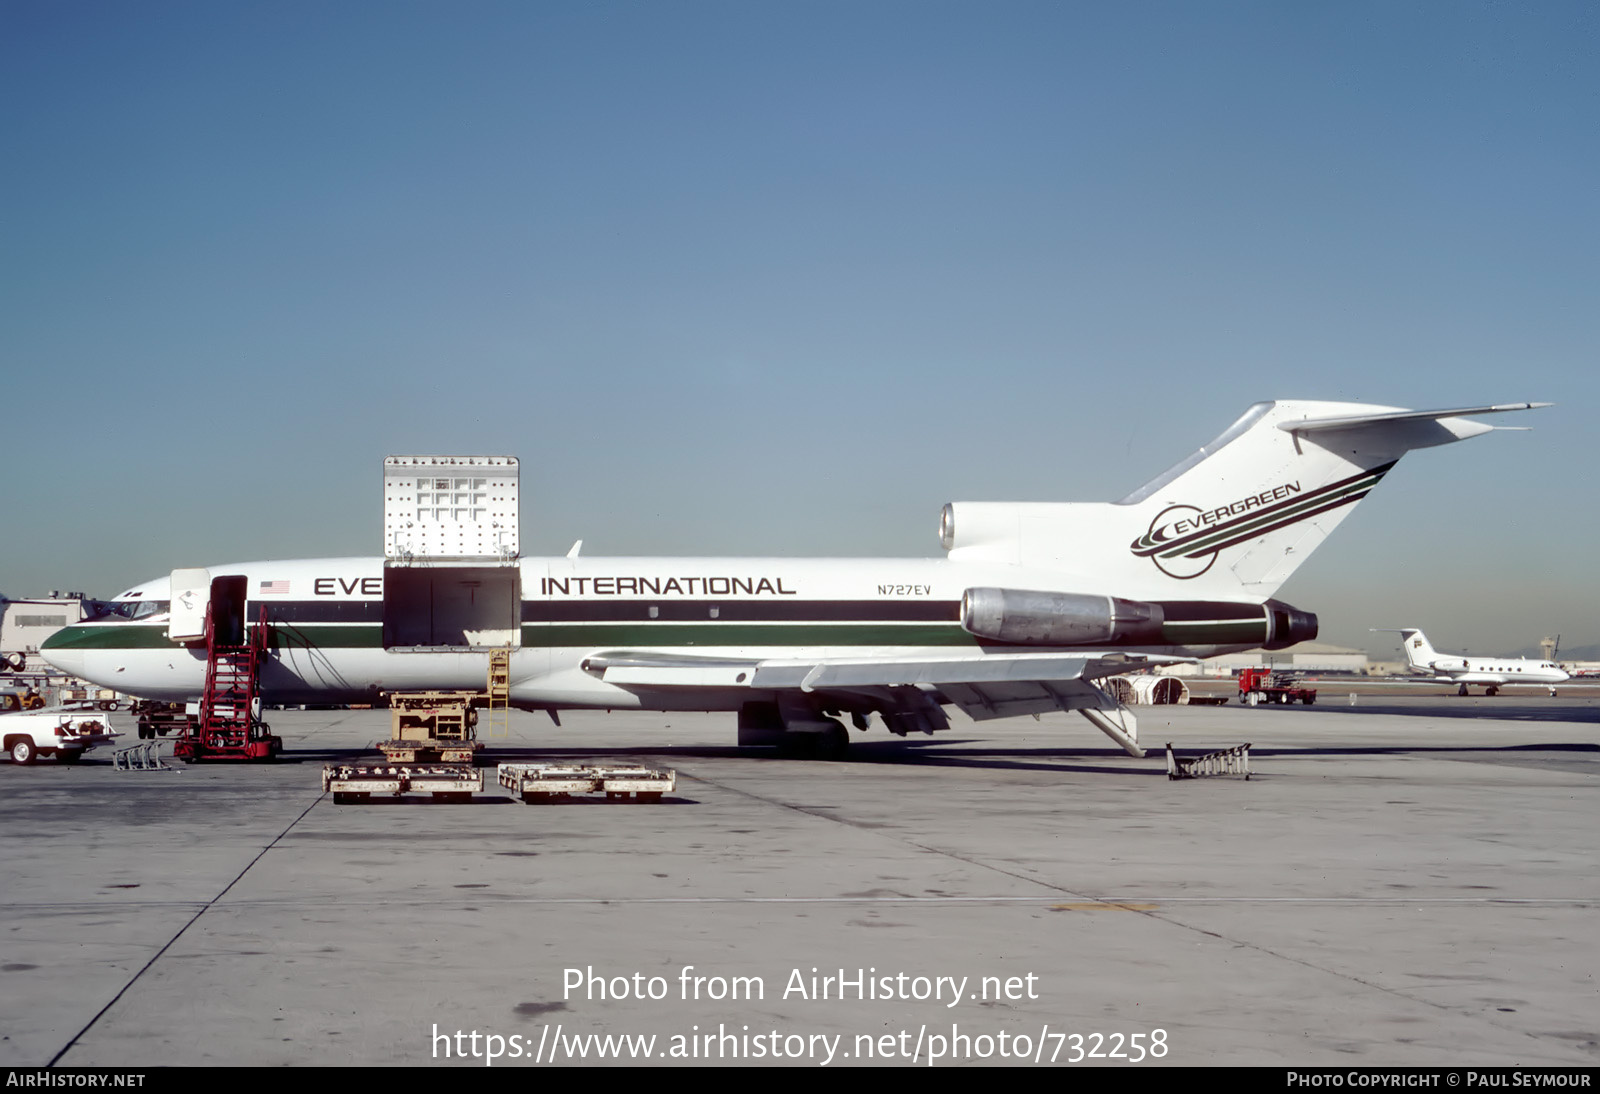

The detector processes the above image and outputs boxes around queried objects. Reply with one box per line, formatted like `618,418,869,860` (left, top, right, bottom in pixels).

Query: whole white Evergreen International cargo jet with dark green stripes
43,401,1547,755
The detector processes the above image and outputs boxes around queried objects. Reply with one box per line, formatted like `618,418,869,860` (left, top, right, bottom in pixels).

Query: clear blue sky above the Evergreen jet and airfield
0,0,1600,653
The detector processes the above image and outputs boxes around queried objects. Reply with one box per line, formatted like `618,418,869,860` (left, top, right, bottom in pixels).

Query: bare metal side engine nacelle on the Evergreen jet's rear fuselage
962,589,1162,646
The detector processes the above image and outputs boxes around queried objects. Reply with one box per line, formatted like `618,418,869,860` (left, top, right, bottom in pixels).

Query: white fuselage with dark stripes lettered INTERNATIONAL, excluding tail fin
45,558,1267,710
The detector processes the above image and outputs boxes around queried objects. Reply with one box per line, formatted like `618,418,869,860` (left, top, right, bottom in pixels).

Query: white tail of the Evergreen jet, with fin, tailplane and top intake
941,401,1549,601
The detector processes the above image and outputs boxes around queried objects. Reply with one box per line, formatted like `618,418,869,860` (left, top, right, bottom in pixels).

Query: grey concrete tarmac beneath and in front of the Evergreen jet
0,697,1600,1068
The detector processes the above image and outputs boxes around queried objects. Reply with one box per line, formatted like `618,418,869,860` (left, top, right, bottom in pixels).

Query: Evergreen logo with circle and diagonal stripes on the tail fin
1128,461,1398,581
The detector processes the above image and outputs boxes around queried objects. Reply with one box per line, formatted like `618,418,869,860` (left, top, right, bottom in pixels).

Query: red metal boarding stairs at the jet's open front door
173,609,283,763
